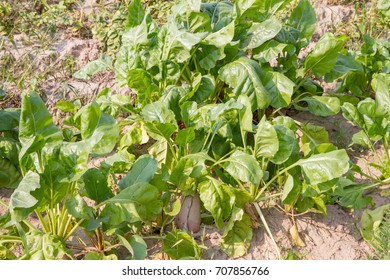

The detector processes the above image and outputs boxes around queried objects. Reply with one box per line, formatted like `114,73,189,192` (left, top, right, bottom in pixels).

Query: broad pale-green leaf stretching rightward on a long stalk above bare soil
296,150,349,185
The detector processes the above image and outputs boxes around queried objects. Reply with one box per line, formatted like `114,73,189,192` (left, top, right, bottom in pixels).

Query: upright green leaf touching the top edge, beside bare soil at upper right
288,0,317,41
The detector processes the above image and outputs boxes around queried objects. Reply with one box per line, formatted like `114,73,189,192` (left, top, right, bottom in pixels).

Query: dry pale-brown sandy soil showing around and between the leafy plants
0,0,390,260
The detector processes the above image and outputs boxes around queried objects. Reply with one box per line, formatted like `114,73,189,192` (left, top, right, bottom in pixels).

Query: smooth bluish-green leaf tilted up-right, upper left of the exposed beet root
118,155,157,189
